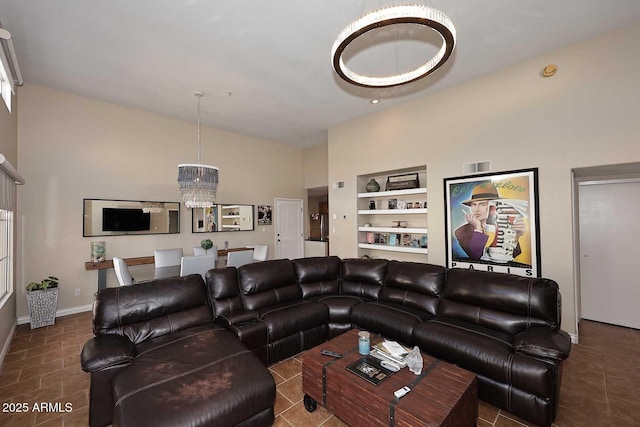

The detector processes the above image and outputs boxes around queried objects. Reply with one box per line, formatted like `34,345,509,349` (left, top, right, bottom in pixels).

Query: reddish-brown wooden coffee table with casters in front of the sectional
302,329,478,427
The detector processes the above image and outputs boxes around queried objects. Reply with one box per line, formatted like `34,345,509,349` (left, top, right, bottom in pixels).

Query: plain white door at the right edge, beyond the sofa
579,181,640,328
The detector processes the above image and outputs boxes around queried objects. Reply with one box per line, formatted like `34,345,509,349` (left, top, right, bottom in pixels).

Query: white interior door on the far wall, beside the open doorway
274,199,304,259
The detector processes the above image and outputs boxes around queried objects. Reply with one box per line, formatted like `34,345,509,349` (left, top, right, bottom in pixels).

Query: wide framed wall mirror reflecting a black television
82,199,180,237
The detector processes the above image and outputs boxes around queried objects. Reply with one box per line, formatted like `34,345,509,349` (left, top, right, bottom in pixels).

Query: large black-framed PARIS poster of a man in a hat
444,168,541,277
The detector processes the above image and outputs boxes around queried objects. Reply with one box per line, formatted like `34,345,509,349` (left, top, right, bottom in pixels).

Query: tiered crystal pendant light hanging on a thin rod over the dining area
178,92,218,208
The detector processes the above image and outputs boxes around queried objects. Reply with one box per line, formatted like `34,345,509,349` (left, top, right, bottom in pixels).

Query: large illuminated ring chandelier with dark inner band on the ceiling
331,5,456,88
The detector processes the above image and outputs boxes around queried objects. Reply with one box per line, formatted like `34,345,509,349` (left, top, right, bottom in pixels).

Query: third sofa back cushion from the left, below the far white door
238,259,302,310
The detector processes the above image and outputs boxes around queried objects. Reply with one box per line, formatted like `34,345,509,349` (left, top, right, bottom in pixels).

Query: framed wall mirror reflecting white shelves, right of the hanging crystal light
191,204,255,233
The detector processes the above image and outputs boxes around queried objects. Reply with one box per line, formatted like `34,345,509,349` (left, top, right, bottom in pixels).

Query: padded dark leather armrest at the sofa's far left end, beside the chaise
80,334,135,372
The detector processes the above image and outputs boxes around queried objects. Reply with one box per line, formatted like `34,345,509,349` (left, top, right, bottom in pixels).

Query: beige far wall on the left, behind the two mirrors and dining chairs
17,85,306,317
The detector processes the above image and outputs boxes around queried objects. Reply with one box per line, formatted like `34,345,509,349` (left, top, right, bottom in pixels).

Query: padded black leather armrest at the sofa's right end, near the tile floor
513,328,571,360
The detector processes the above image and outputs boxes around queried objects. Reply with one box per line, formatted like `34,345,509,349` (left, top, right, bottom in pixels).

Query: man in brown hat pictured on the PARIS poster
455,182,527,260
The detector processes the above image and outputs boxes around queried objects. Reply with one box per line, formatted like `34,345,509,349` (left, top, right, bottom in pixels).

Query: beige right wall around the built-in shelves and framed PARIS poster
329,26,640,334
